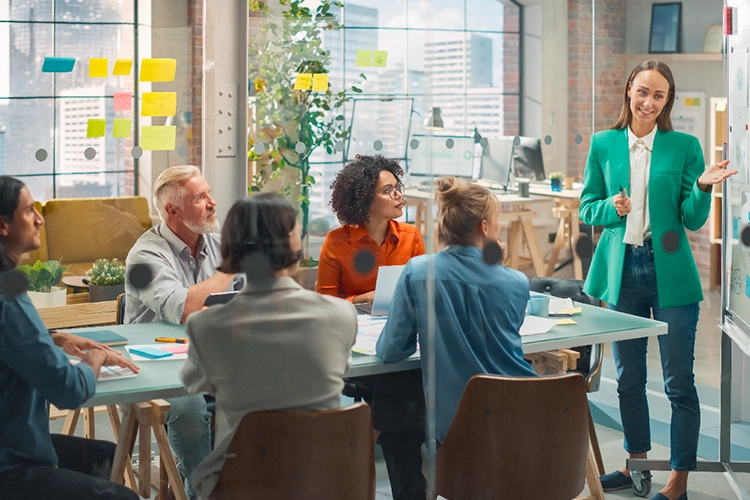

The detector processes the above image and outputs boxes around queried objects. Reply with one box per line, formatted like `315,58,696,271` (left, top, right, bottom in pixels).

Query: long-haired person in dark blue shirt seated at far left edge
0,176,138,500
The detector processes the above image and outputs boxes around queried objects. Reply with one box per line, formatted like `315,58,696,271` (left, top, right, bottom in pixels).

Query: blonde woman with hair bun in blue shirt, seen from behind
376,177,536,443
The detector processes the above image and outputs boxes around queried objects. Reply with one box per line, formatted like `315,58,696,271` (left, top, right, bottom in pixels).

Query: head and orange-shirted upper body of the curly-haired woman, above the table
315,155,424,304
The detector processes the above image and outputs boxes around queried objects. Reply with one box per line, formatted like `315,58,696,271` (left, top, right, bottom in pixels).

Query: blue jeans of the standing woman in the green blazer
609,240,700,471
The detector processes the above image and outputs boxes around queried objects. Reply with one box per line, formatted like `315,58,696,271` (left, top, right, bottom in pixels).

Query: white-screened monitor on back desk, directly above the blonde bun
409,134,474,179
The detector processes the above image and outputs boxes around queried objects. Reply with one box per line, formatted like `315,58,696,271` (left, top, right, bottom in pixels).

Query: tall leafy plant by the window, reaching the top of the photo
248,0,366,248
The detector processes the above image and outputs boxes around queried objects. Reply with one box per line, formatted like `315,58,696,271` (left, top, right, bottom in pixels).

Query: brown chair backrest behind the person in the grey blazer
210,403,375,500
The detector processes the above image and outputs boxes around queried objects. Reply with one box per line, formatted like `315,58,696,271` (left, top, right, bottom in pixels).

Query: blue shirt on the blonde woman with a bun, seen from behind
377,246,536,442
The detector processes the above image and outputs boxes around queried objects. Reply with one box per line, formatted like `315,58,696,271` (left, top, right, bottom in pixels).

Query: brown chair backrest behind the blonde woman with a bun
436,373,589,500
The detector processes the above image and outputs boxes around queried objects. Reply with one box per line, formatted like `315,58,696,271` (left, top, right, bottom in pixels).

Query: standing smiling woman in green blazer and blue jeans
579,61,736,500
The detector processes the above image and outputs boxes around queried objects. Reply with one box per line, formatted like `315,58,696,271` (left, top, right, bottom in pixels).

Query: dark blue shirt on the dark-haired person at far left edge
0,280,96,474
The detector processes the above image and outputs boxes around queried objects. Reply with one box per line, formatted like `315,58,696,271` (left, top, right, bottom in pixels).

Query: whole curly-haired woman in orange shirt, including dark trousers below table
315,155,426,500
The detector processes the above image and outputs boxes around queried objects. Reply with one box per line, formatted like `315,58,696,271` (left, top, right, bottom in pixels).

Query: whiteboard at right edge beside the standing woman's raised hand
722,0,750,337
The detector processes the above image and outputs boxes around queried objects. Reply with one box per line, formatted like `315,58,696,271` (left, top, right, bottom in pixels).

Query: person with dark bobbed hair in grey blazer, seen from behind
180,193,357,498
